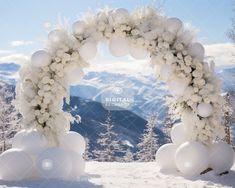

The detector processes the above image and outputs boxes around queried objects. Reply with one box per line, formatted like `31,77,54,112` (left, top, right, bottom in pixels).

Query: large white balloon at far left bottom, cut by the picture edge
0,149,33,181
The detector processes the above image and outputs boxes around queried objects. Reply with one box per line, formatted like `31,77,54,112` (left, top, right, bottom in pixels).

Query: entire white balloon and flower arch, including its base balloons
0,8,233,179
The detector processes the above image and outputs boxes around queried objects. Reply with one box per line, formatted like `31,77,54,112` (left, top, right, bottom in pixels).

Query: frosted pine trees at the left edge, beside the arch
0,85,21,152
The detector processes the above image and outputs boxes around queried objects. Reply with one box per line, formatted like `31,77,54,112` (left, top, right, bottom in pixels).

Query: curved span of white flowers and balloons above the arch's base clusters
16,8,224,145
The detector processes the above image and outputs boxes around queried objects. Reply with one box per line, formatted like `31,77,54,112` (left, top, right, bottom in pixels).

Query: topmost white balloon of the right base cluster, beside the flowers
171,123,187,145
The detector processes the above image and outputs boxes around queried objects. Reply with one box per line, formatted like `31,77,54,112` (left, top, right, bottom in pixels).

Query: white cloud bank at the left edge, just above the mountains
0,53,29,65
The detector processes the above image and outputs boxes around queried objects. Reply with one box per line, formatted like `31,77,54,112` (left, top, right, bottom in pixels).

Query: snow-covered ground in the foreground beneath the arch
0,162,235,188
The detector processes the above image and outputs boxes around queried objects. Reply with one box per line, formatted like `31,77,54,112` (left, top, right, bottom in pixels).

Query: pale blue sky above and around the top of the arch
0,0,233,53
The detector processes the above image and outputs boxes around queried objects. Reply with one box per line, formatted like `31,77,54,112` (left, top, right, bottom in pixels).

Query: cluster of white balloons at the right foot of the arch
156,123,234,177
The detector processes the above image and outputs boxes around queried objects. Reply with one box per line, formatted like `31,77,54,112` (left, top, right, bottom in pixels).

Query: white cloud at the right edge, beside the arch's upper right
204,43,235,67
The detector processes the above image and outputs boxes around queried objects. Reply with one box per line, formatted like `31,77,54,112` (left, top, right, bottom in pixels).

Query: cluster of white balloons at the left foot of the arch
0,130,85,181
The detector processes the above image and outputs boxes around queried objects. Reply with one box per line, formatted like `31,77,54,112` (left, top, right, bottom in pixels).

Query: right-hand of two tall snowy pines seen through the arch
136,113,158,162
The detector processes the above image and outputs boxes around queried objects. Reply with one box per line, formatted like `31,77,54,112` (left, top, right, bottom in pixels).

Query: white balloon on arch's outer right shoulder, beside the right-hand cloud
188,42,205,61
